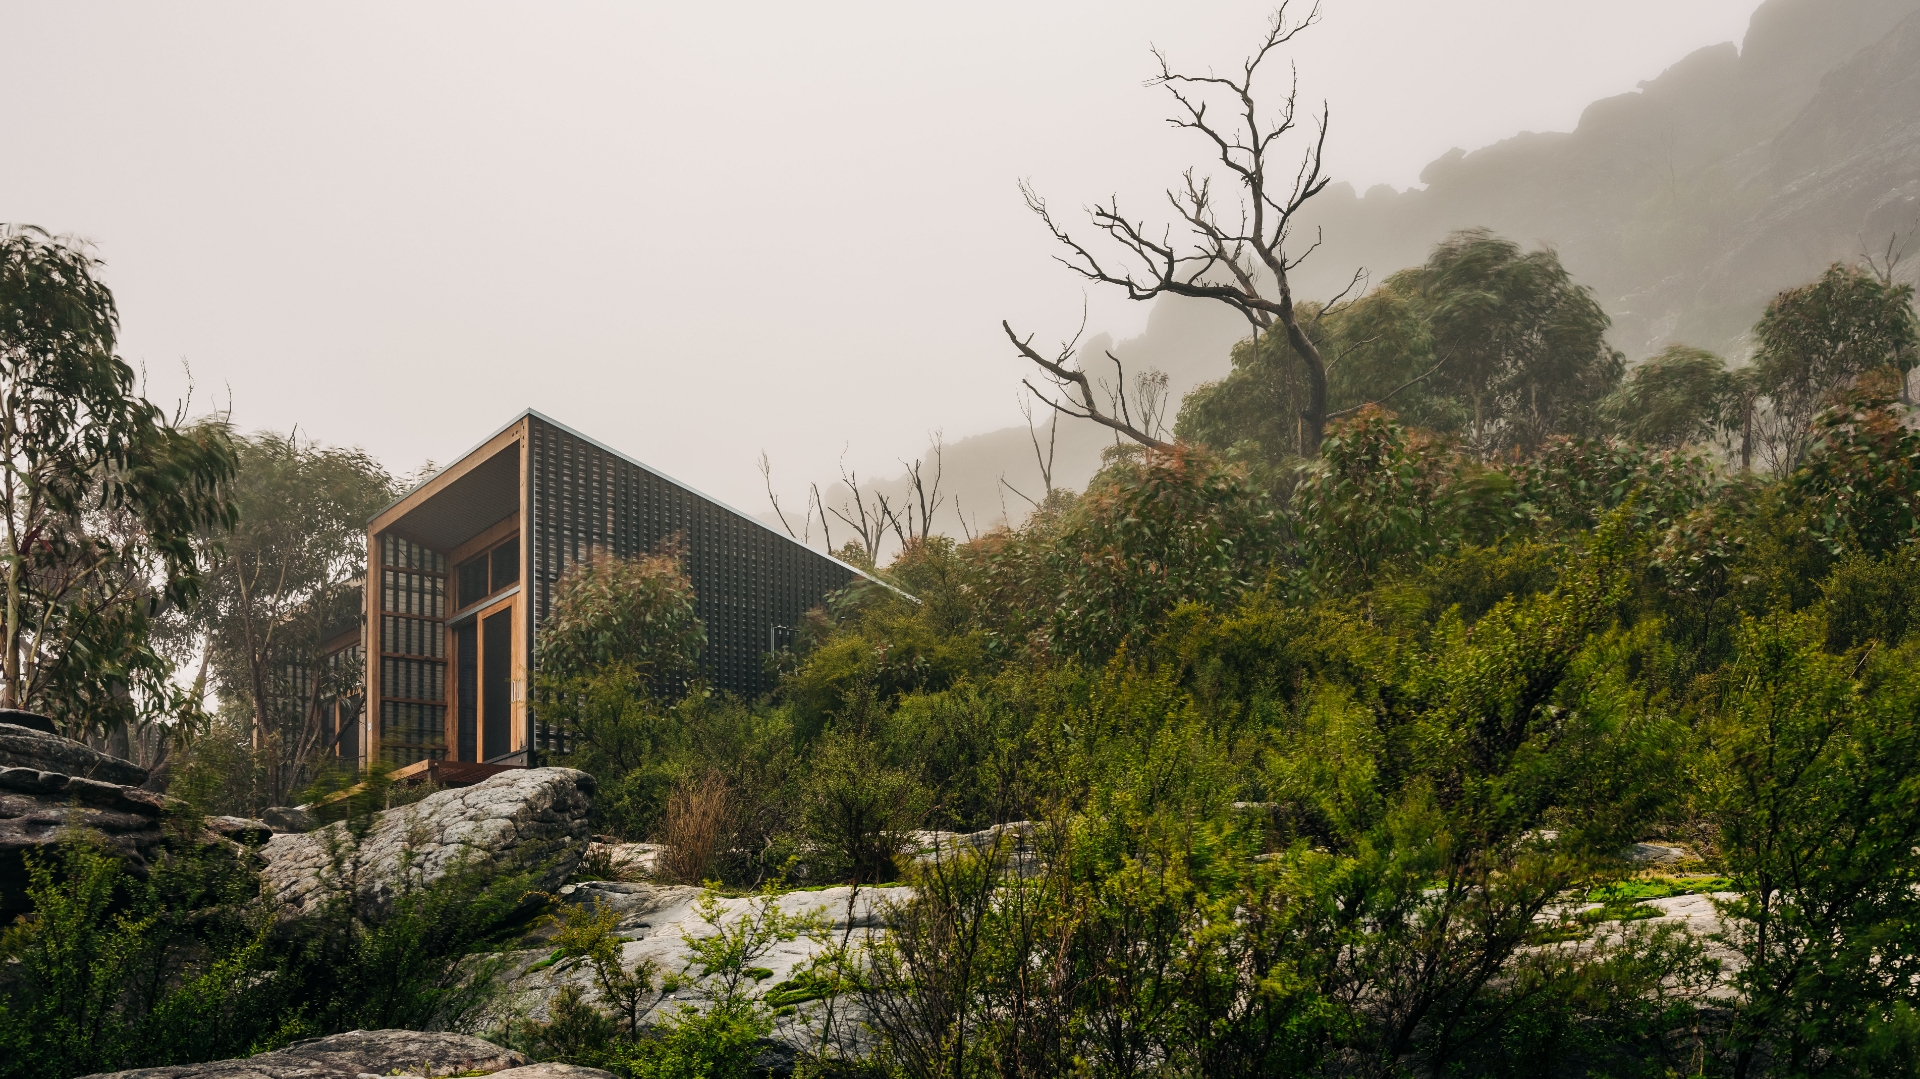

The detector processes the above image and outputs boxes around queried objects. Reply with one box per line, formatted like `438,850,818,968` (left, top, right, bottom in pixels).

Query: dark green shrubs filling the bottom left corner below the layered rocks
0,816,532,1077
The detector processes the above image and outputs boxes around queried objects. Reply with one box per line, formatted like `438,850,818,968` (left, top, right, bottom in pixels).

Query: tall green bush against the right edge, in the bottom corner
1695,612,1920,1075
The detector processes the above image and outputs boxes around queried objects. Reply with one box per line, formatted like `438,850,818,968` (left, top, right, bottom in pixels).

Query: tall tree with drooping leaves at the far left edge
0,225,234,733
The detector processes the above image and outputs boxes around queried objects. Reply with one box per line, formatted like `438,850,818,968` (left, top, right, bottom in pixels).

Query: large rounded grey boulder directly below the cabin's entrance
261,768,593,920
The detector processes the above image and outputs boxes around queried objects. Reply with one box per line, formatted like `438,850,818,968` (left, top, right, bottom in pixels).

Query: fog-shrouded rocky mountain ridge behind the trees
768,0,1920,543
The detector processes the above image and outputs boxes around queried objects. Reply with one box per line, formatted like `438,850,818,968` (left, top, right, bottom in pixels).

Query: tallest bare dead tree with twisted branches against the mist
1000,4,1363,455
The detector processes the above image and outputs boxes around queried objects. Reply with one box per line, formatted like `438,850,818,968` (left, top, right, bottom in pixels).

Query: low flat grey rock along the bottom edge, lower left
84,1031,526,1079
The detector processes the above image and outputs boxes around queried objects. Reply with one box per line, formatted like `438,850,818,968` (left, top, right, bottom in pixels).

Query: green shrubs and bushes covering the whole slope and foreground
26,234,1920,1079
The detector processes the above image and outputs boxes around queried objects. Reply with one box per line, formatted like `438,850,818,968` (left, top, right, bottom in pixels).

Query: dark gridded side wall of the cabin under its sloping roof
524,415,856,751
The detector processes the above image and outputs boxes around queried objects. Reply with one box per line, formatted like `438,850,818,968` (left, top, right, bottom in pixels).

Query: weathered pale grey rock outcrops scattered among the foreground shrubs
0,714,1738,1079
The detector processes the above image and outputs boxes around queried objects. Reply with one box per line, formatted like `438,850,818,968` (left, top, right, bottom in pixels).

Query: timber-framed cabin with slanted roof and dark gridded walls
324,409,864,767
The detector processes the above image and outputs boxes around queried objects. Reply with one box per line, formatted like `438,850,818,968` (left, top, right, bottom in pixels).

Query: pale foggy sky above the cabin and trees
0,0,1755,513
